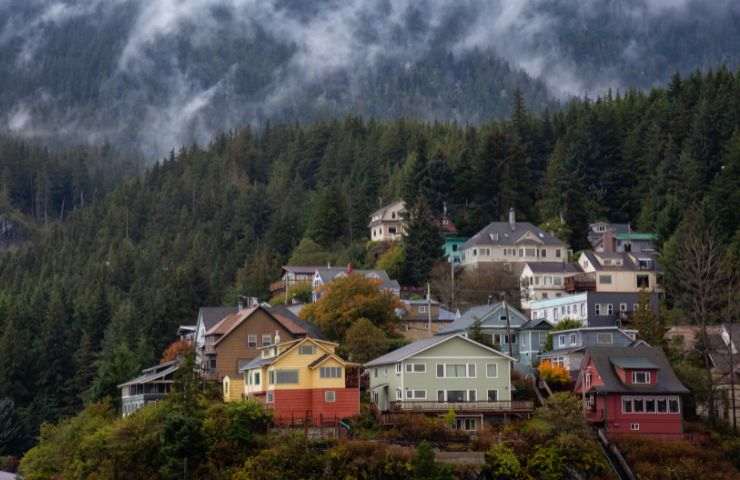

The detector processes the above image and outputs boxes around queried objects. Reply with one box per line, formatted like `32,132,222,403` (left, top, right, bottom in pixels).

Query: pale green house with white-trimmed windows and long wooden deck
365,334,532,430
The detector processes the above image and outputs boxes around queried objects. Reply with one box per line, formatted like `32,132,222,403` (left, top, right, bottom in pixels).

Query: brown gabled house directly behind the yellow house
203,305,322,381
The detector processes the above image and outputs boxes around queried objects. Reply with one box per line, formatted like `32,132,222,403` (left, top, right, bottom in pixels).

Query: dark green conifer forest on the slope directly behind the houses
0,68,740,448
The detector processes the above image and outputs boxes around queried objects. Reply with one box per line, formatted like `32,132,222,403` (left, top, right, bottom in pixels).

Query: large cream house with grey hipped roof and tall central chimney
460,209,568,276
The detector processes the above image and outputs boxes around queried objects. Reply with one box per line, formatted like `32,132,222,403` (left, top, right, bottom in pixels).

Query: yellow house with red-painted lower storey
230,337,360,423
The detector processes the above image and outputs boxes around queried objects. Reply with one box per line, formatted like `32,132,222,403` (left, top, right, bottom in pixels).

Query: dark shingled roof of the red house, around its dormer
576,345,689,394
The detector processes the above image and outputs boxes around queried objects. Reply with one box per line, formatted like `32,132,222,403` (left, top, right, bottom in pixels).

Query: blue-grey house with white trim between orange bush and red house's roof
539,327,645,378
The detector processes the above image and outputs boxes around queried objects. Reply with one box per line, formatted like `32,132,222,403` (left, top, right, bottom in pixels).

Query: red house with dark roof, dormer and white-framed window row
575,344,689,437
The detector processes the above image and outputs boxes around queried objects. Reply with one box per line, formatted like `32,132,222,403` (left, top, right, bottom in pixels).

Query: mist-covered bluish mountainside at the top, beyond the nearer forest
0,0,740,155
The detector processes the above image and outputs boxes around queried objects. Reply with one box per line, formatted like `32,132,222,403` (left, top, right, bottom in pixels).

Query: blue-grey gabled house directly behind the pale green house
438,302,529,358
